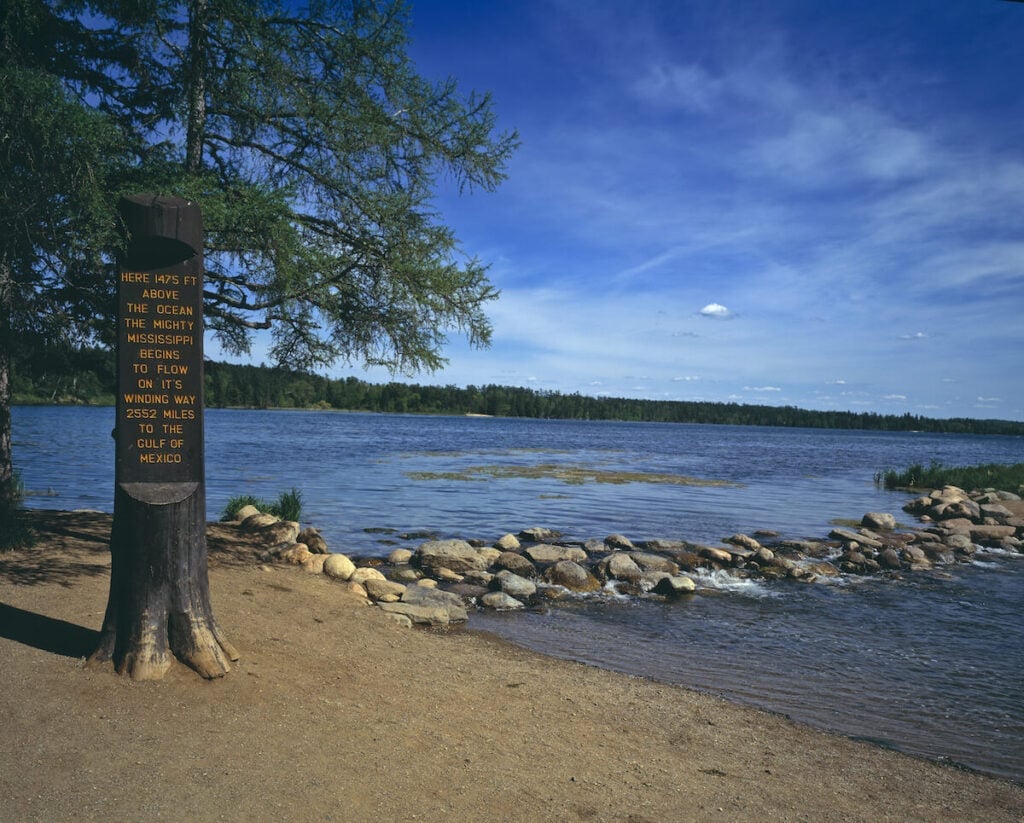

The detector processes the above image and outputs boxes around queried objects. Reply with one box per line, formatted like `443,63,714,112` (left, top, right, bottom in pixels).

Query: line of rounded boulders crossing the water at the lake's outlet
226,486,1024,626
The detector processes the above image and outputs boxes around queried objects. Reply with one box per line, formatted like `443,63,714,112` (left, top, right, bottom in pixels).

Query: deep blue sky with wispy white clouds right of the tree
260,0,1024,420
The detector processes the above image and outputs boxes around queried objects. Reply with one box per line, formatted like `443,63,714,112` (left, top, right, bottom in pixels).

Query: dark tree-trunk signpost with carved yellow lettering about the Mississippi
90,194,238,680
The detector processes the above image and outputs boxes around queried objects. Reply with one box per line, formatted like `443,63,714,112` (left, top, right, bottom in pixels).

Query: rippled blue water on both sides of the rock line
13,406,1024,781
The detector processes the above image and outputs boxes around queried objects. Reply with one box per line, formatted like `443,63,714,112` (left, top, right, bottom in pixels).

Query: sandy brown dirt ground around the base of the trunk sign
0,512,1024,823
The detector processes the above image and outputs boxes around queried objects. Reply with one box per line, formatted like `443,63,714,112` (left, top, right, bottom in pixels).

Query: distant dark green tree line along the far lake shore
13,349,1024,435
